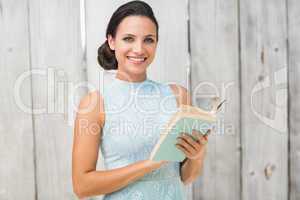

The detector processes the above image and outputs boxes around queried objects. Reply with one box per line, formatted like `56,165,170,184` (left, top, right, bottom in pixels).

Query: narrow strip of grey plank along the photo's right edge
287,0,300,200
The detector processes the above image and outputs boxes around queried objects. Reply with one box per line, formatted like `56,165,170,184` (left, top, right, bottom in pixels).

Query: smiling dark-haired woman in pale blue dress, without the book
72,1,207,200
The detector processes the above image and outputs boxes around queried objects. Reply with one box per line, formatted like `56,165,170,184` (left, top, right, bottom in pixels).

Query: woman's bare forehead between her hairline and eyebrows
117,16,156,36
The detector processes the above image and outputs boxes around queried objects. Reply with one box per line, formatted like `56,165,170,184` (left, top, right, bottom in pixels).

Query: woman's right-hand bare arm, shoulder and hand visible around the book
170,84,207,184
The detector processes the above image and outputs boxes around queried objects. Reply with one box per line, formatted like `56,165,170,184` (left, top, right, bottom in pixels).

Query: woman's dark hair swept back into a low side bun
98,1,158,70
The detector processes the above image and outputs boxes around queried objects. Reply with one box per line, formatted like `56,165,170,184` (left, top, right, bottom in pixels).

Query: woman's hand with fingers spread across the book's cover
176,130,211,160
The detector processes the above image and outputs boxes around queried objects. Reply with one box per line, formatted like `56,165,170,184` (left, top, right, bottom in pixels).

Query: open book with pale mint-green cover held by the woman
150,99,225,162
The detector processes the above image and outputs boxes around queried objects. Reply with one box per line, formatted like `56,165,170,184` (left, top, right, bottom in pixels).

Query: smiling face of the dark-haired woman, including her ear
108,16,157,77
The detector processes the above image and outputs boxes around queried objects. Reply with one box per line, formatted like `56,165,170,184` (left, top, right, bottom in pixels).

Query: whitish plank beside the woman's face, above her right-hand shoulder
146,0,189,87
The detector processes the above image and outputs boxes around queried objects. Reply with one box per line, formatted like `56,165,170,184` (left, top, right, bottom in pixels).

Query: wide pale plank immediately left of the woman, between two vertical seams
30,0,86,200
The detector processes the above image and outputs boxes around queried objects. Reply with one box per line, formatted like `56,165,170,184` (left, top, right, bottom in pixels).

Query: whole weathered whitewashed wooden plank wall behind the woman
0,0,300,200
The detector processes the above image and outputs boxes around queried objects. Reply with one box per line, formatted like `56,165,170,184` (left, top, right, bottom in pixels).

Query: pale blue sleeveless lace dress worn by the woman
100,78,186,200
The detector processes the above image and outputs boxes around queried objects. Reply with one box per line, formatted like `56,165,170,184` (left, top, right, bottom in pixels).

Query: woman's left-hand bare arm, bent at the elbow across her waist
72,91,164,198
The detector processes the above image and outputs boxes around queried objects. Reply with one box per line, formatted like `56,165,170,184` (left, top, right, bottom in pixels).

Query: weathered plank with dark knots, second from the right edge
240,0,288,200
